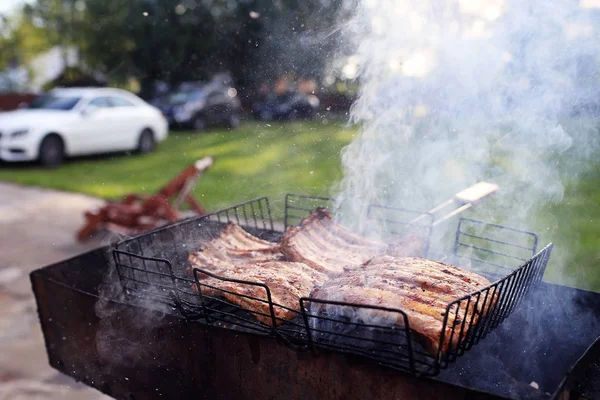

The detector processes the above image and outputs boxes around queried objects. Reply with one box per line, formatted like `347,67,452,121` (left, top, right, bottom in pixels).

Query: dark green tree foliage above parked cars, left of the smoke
0,0,350,96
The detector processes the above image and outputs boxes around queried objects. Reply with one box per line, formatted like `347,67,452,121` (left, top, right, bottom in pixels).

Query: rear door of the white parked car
109,95,144,150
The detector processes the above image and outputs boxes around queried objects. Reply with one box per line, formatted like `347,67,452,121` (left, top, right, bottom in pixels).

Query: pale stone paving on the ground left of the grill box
0,182,109,400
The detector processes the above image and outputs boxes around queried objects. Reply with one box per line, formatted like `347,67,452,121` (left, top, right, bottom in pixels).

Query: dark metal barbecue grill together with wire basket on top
32,195,600,398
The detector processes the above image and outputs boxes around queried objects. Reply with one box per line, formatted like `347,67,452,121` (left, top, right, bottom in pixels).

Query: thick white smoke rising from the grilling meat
337,0,599,241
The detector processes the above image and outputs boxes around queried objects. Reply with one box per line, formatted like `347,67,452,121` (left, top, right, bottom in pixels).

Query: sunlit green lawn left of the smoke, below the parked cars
0,122,356,217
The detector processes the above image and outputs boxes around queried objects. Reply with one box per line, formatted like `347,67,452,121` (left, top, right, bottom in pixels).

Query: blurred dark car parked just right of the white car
157,87,241,131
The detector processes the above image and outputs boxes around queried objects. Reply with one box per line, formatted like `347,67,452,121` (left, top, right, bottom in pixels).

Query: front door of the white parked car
71,96,116,154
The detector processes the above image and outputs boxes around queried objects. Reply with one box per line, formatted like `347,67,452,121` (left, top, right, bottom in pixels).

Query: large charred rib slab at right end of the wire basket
312,256,496,355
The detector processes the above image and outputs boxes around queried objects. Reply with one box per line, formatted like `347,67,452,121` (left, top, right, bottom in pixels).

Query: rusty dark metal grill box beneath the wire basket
31,248,600,400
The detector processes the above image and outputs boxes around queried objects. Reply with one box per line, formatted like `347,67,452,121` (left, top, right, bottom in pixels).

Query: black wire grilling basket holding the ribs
113,195,552,376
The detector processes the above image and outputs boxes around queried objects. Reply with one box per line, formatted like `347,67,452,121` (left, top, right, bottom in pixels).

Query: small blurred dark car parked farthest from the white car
252,92,320,121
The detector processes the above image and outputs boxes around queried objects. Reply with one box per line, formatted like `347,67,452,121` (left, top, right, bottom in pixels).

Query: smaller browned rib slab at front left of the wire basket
199,261,327,326
